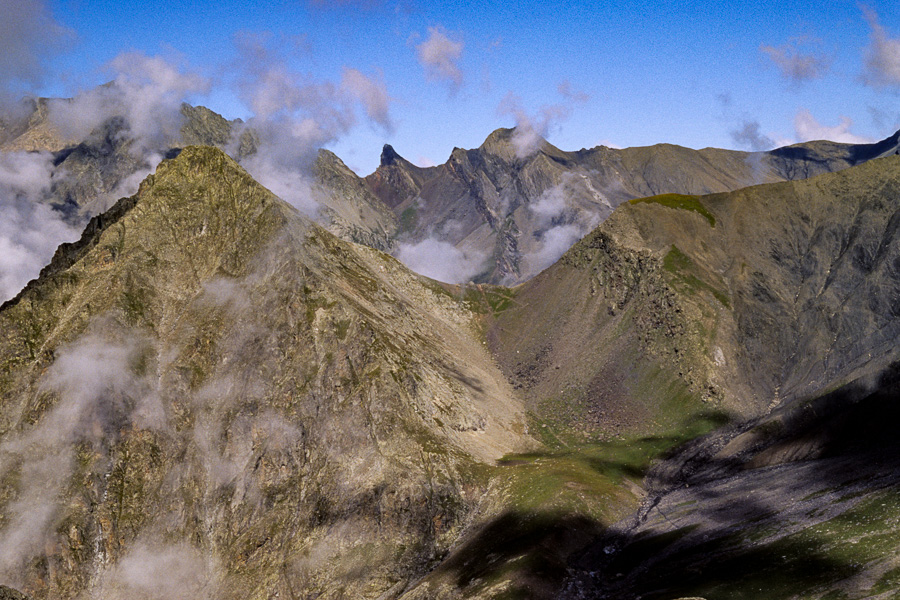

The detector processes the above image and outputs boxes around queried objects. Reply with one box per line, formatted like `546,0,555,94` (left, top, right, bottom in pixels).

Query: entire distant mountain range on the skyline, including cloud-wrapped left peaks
0,99,900,285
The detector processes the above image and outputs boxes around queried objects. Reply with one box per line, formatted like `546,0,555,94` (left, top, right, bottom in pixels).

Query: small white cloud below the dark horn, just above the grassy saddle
394,238,486,283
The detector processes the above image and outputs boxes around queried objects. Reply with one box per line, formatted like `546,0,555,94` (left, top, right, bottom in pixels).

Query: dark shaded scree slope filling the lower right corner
563,364,900,600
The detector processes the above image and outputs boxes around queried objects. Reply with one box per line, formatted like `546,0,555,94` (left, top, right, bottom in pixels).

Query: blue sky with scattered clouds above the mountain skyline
0,0,900,174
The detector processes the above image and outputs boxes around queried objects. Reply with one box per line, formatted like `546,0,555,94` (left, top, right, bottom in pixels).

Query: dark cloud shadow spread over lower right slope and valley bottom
430,365,900,600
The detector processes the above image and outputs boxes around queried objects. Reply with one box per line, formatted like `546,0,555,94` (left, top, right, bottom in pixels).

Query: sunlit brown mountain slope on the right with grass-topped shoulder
490,157,900,432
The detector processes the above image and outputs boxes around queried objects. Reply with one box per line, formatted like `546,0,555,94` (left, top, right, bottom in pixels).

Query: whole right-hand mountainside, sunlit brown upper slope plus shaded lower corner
478,156,900,599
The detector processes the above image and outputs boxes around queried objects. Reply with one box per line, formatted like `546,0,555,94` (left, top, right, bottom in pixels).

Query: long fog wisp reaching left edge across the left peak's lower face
0,319,165,579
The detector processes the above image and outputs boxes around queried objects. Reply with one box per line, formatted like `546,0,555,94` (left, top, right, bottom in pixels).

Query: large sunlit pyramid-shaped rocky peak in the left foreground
0,147,534,598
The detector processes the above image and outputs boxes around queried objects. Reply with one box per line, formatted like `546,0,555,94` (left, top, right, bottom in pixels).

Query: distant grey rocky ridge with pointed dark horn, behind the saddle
366,129,898,284
